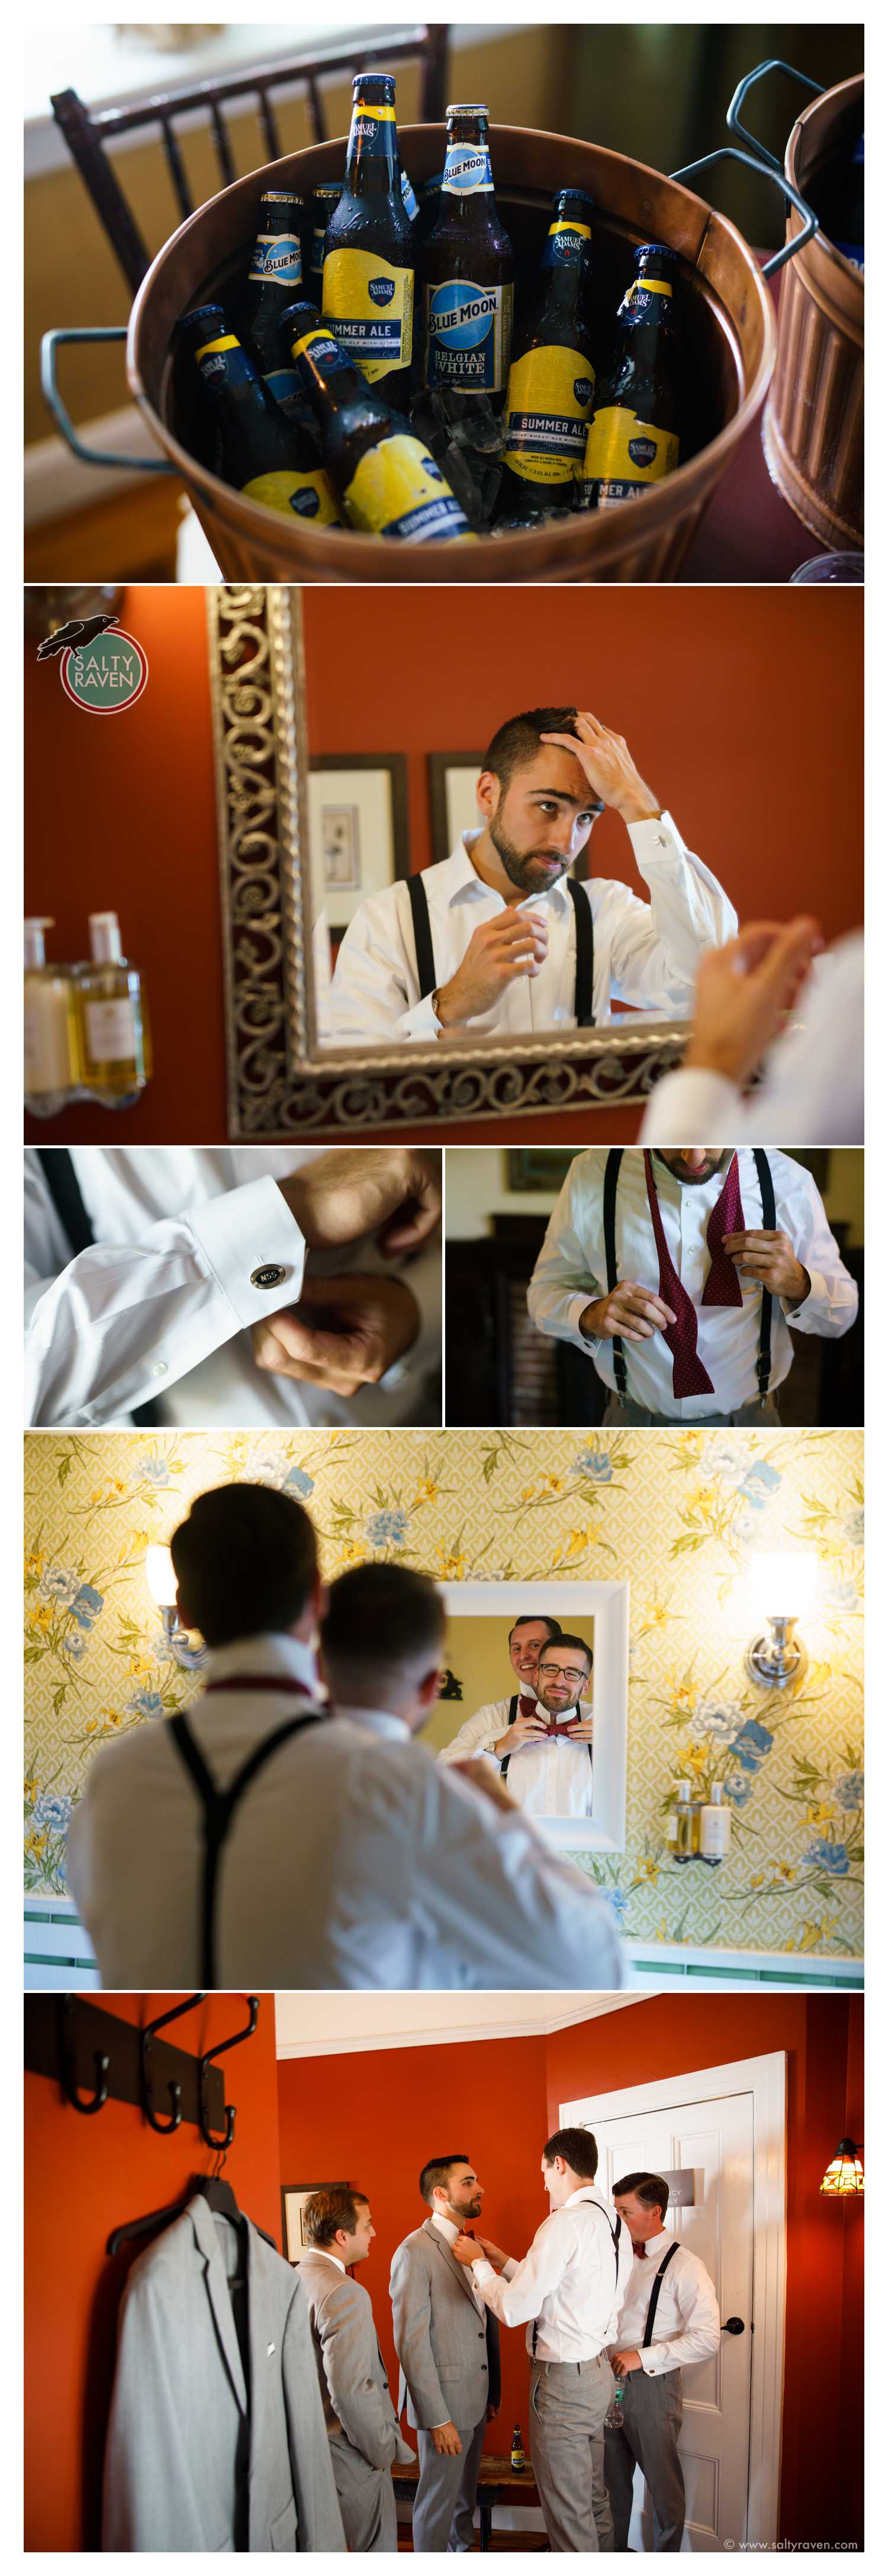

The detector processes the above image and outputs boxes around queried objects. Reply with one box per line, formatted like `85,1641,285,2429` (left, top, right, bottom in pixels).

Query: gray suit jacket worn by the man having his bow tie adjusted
391,2218,499,2432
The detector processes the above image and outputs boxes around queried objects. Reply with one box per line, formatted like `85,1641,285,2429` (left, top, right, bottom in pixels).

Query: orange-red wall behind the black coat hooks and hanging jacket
25,1994,281,2550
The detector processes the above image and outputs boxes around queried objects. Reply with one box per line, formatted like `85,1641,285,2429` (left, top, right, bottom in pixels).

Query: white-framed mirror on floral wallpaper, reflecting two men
422,1582,628,1852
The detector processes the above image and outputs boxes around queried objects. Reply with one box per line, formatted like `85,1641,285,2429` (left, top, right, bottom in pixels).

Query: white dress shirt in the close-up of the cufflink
25,1144,440,1429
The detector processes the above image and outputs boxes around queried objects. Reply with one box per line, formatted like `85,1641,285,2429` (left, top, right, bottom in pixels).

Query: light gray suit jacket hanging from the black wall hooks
103,2197,345,2553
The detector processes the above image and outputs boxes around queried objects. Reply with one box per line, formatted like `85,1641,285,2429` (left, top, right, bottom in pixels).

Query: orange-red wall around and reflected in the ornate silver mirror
25,585,863,1144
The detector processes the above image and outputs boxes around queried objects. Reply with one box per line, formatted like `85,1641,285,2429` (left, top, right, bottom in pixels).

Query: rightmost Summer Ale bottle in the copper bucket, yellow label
584,242,680,510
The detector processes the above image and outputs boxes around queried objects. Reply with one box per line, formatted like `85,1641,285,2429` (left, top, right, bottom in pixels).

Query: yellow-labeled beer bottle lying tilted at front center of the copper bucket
281,304,471,543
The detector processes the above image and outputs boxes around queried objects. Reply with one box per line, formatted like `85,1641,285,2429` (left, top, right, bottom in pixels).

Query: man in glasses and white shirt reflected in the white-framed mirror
440,1628,592,1816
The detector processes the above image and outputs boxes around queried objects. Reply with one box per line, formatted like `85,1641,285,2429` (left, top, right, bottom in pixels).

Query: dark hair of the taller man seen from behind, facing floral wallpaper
170,1484,317,1646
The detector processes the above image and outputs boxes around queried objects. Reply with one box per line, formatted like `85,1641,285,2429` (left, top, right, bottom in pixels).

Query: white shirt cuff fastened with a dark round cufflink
188,1175,306,1324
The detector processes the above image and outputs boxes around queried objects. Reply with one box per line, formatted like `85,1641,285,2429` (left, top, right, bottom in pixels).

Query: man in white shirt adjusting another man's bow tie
453,2128,630,2550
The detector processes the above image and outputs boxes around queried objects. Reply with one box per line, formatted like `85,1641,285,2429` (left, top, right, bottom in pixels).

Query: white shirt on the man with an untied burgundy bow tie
527,1147,857,1422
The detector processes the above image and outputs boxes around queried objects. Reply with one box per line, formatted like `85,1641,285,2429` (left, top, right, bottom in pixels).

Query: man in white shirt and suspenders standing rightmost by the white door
605,2174,720,2550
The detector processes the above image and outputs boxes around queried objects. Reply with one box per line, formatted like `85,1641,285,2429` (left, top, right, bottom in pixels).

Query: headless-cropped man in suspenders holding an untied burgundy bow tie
527,1147,857,1425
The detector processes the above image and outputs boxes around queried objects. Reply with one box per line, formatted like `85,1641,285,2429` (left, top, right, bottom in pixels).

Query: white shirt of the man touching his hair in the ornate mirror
327,814,736,1046
